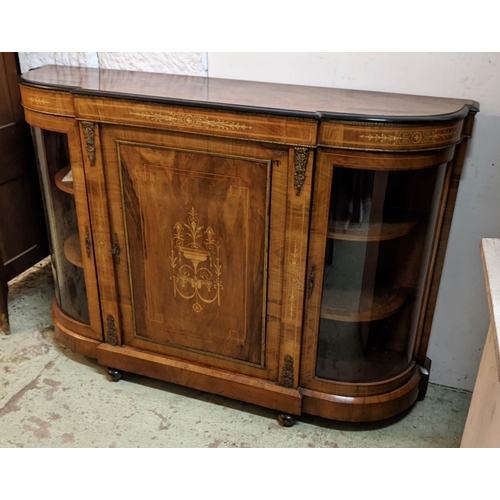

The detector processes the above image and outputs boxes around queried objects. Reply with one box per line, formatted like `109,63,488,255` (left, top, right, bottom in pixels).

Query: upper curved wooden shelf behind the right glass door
327,215,418,241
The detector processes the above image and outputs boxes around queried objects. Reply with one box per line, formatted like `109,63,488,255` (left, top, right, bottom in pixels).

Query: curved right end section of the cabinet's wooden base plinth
301,369,421,422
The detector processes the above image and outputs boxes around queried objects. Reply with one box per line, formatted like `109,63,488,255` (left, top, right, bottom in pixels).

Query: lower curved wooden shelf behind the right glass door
321,286,412,323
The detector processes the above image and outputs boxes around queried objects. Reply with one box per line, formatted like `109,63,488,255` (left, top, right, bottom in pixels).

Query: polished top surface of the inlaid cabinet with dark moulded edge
20,66,478,122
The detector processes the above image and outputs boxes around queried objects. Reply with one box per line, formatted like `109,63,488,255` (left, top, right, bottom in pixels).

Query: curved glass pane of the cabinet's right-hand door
316,165,446,382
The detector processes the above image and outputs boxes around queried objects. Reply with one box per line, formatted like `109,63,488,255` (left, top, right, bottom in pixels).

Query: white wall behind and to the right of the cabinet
20,52,500,390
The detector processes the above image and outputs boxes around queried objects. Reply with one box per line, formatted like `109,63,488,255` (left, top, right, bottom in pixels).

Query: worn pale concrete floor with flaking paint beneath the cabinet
0,261,471,448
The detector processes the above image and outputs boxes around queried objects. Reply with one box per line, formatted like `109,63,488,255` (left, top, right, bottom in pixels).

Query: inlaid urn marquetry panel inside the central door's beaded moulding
114,142,270,365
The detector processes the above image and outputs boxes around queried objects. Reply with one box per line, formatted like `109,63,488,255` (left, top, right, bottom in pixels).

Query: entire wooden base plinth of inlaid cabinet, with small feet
53,302,422,427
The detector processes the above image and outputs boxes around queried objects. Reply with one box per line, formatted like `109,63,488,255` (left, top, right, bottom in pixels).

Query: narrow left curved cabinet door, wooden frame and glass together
27,112,102,340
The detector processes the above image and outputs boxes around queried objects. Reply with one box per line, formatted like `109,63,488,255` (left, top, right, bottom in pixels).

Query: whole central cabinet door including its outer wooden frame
101,126,287,378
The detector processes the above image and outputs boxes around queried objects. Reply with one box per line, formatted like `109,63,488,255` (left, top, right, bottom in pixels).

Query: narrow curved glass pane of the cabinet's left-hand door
33,128,90,323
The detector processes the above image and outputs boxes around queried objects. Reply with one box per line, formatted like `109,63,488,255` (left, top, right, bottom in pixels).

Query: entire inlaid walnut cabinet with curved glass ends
21,66,478,425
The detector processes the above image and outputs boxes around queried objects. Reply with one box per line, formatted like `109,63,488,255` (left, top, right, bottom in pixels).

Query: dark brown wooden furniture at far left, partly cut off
0,52,49,334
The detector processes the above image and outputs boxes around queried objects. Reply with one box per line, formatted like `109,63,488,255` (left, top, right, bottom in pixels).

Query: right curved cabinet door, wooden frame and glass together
301,148,453,396
